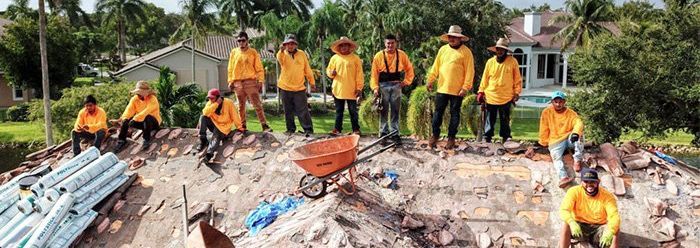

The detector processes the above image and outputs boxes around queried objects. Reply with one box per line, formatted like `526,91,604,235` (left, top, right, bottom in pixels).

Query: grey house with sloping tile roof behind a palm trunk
114,36,276,91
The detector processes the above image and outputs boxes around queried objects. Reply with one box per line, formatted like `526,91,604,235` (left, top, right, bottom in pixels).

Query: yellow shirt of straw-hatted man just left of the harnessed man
326,53,365,100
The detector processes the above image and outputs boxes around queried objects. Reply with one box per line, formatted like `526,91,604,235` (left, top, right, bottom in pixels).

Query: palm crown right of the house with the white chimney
549,0,614,51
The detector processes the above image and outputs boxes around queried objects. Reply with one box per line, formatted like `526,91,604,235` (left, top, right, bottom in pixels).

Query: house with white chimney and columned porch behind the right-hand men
506,11,619,91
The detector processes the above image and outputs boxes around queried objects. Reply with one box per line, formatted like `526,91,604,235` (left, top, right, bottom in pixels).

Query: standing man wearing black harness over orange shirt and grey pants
370,34,414,142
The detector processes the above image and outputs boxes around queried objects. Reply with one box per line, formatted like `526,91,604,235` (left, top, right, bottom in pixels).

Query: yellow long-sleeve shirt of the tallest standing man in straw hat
428,44,474,95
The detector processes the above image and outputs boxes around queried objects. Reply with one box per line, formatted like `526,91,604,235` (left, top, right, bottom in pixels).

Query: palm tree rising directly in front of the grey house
171,0,216,82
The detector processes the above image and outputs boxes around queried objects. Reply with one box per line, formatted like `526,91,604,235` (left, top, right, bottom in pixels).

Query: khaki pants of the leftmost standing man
229,80,267,126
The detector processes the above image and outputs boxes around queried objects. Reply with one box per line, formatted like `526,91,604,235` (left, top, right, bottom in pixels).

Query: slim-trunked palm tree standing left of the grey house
95,0,146,63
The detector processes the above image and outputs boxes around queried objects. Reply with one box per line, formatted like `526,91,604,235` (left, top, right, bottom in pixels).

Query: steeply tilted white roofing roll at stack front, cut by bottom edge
25,193,75,248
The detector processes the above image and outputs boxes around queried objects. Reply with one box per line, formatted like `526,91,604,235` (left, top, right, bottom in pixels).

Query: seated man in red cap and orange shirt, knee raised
197,89,245,161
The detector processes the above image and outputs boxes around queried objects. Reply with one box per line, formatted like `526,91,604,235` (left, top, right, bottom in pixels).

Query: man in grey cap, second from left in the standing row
277,34,316,136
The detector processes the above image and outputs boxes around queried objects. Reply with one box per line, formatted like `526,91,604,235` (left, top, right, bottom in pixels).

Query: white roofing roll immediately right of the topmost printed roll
55,152,119,194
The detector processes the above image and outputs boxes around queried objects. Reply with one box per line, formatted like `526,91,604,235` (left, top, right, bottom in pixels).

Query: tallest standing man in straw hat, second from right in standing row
426,25,474,149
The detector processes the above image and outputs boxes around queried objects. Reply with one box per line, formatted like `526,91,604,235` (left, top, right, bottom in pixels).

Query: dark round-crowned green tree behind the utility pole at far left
0,16,78,99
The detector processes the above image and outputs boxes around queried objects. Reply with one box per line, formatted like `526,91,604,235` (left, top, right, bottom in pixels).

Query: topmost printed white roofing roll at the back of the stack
31,146,100,197
